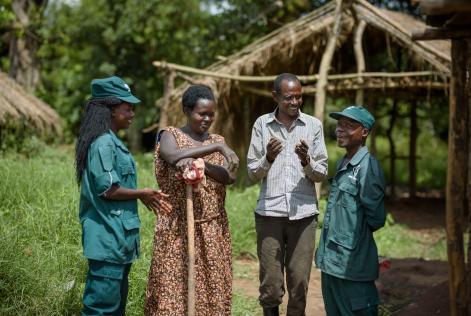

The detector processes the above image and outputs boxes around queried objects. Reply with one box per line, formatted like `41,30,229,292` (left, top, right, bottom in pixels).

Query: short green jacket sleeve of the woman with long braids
90,145,120,195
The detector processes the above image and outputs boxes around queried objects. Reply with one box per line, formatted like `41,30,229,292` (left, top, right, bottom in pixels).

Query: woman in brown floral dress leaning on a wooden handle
144,85,239,316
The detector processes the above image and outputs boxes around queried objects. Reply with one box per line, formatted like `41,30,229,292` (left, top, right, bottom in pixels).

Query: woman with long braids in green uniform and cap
76,77,170,315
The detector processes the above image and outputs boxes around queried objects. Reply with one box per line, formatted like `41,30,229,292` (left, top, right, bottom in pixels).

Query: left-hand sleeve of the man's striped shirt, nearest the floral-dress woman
247,119,271,181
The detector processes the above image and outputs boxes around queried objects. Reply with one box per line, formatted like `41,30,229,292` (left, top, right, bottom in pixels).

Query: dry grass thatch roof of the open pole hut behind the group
153,0,451,149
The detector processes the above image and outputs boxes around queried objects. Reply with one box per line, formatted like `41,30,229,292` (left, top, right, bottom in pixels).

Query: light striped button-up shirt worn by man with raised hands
247,110,327,220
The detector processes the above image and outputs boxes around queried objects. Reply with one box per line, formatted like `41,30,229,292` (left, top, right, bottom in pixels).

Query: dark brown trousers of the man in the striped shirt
255,214,317,316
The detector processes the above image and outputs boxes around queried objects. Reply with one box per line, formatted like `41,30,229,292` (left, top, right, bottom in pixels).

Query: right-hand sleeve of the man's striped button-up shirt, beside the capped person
304,125,327,182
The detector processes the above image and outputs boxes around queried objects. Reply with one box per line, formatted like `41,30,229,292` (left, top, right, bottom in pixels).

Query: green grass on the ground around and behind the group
0,147,446,315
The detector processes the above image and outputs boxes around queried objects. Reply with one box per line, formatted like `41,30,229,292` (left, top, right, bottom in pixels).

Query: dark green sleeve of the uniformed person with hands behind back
360,159,386,231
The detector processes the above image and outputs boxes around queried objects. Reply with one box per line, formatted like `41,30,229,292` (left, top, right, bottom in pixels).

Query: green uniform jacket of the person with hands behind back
316,146,386,281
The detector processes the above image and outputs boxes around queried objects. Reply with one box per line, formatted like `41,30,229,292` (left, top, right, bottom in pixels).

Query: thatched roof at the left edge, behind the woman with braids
0,71,61,134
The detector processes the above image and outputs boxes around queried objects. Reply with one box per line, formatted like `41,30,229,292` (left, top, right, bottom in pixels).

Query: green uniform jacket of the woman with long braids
79,130,140,264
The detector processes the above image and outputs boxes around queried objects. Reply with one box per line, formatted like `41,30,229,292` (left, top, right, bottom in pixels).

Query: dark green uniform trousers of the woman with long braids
82,260,131,316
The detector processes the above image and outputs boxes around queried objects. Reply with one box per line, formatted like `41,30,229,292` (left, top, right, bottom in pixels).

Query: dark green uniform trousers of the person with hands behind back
321,272,379,316
